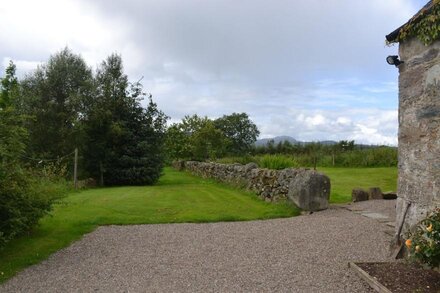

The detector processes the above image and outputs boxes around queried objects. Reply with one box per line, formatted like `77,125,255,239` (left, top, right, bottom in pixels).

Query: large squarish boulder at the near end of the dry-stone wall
287,169,330,212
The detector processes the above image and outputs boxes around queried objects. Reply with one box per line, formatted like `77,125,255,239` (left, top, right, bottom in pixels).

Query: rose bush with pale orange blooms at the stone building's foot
405,208,440,268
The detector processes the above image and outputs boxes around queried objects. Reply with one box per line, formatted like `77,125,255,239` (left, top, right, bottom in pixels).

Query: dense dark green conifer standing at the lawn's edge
84,54,167,185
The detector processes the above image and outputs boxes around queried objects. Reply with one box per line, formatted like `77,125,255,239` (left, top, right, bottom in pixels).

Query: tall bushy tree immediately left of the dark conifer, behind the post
20,48,92,158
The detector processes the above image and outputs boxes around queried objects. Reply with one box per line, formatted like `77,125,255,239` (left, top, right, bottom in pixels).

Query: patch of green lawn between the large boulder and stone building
318,167,397,203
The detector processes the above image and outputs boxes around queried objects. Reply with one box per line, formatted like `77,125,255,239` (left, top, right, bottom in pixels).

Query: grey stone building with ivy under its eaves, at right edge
386,0,440,232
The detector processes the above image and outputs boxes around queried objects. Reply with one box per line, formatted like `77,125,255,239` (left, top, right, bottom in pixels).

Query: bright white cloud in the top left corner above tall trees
0,0,129,74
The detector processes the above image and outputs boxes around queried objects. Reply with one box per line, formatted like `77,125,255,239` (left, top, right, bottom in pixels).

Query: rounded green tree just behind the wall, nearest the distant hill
214,113,260,155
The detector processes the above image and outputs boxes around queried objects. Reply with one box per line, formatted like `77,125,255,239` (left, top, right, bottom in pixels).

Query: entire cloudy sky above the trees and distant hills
0,0,428,145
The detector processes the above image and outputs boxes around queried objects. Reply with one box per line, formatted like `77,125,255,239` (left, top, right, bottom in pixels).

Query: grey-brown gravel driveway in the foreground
0,200,391,292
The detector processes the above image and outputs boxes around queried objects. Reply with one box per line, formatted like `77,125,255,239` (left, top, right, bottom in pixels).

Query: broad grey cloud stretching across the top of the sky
85,0,416,85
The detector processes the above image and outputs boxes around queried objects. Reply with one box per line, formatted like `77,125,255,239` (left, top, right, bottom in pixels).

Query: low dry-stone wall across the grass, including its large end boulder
173,161,330,211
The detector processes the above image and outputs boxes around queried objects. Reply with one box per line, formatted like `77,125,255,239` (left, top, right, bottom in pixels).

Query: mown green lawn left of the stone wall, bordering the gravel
0,169,299,283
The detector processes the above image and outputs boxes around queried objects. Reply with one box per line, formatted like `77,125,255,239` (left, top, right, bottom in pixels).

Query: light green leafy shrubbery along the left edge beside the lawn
0,62,68,248
